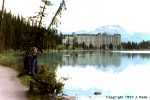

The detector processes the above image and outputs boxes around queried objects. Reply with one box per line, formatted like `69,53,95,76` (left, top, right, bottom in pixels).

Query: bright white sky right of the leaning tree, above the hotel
60,0,150,32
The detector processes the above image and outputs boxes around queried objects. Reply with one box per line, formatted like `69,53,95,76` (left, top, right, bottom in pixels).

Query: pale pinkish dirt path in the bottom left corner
0,65,27,100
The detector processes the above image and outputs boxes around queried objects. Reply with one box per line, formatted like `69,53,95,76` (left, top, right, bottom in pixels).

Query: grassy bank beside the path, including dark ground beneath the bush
0,51,61,100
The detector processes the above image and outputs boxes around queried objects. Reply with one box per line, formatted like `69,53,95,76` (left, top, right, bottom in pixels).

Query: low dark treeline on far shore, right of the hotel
122,40,150,49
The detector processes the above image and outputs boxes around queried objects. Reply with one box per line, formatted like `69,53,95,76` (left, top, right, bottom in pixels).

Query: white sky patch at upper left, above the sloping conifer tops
3,0,41,17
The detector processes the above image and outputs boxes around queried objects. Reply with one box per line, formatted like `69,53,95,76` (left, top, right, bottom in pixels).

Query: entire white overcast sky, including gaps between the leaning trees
0,0,150,34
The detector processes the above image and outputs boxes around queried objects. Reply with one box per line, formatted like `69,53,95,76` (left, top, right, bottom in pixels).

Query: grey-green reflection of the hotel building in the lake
62,52,121,67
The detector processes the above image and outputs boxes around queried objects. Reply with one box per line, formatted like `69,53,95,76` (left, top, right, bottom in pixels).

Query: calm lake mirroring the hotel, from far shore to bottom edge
39,51,150,100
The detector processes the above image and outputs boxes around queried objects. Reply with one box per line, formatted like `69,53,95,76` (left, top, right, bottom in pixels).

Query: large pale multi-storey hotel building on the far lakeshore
63,33,121,48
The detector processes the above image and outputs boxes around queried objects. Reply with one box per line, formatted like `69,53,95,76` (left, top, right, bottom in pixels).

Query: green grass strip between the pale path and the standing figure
0,51,31,100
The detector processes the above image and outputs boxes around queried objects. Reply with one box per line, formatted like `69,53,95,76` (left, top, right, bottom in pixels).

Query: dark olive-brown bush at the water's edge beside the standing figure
30,65,64,96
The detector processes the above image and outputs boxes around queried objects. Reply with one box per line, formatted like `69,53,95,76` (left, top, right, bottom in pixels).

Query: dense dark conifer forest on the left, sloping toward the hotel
0,11,61,51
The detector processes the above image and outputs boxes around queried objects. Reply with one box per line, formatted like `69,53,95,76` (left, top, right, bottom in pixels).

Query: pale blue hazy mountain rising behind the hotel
63,25,150,42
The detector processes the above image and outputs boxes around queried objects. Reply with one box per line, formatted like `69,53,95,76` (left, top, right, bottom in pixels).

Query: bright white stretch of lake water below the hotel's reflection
58,64,150,97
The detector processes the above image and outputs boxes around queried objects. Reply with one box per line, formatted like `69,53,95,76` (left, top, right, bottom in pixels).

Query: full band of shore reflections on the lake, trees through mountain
39,51,150,68
